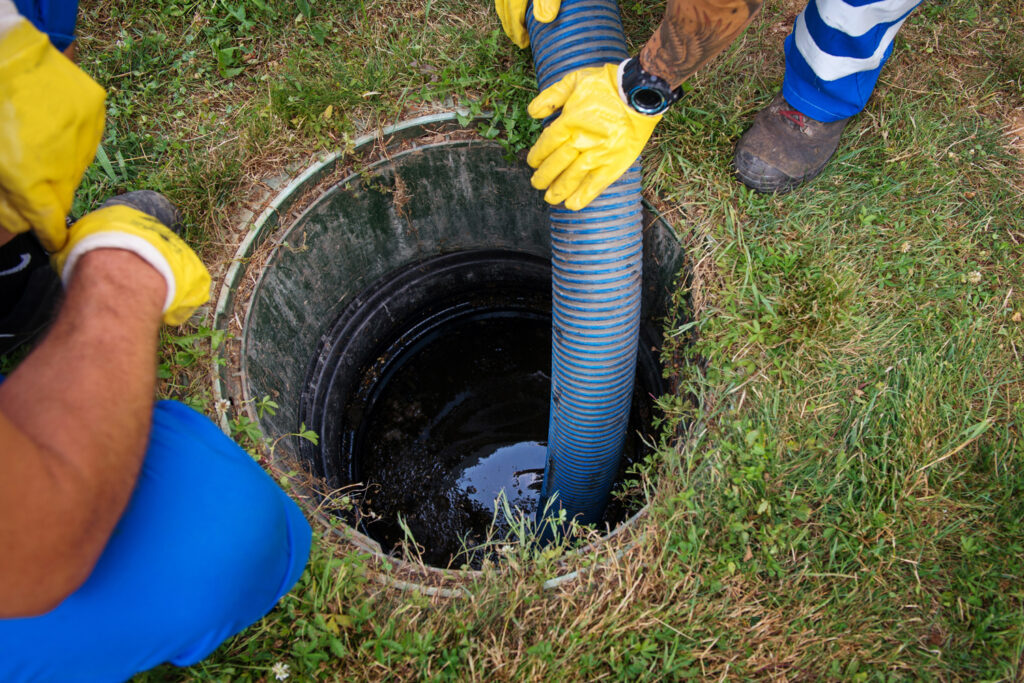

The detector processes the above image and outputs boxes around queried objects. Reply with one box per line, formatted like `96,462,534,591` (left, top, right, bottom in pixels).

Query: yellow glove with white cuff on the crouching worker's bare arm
52,206,210,325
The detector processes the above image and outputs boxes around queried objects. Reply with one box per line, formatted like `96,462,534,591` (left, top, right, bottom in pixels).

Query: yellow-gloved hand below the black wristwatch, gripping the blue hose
526,63,662,211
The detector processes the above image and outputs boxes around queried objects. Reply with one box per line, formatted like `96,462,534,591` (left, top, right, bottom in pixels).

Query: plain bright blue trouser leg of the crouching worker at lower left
0,401,311,682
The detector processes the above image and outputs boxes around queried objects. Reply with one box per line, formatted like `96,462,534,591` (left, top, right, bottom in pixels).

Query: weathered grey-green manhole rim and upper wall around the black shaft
213,112,683,595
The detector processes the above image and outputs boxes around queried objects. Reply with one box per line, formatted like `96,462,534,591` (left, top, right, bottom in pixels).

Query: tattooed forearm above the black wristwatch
640,0,762,87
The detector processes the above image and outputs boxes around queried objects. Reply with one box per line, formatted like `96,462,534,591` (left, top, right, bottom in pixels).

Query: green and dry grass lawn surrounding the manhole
34,0,1024,681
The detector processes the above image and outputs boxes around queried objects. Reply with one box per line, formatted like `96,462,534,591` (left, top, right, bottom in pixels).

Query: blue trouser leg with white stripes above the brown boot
782,0,922,121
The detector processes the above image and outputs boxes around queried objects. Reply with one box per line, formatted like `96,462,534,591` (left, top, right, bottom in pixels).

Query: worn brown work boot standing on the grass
732,92,850,193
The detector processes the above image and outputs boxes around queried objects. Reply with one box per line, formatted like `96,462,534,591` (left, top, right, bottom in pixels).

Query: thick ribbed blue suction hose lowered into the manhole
526,0,643,524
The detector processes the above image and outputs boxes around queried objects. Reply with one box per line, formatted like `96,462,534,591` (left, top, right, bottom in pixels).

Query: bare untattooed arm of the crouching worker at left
0,250,165,612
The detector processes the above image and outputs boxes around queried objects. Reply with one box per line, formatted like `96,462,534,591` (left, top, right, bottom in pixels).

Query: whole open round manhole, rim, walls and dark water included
211,116,682,567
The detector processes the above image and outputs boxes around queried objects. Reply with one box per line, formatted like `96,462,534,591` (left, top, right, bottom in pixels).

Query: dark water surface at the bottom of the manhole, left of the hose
354,311,635,567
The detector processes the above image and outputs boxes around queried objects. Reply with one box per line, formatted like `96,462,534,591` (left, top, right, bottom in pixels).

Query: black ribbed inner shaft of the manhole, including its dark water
301,251,663,568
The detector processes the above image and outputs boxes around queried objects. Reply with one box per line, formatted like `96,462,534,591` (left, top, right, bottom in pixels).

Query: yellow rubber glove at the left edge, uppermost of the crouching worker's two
0,19,106,252
